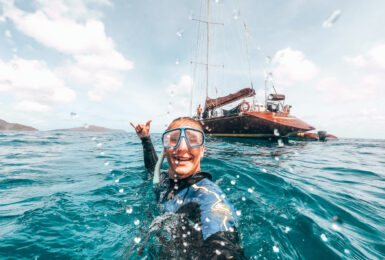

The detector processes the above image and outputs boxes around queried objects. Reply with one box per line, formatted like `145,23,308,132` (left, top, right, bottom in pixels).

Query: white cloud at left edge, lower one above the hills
0,58,76,111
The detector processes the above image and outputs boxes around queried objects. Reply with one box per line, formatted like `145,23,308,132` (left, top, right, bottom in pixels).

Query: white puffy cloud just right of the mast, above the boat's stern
272,48,319,86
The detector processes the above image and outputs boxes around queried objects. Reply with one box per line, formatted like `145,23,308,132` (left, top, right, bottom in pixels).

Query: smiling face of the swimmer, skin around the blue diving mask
164,119,205,179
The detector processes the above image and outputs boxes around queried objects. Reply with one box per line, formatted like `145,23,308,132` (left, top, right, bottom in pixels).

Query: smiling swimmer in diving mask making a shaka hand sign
131,117,245,259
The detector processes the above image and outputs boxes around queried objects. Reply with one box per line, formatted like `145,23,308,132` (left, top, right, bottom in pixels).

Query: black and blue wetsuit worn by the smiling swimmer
141,137,245,259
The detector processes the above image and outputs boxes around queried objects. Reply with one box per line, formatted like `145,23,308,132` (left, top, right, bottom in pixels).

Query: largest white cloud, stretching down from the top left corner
3,0,133,101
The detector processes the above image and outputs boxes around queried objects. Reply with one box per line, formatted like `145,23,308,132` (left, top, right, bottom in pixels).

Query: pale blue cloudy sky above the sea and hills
0,0,385,139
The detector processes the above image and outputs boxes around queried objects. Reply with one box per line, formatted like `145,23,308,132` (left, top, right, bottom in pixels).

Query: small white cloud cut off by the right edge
345,43,385,70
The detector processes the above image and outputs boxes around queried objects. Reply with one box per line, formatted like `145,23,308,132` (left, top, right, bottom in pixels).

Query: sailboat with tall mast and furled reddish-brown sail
191,0,315,138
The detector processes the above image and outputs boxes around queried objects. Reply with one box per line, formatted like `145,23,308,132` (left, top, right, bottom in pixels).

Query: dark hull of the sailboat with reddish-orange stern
200,112,314,138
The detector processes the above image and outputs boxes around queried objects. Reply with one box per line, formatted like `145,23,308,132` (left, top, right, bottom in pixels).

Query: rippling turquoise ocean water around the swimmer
0,132,385,259
